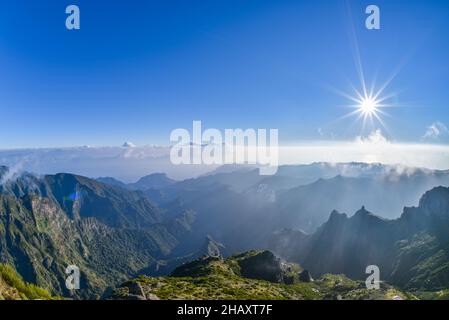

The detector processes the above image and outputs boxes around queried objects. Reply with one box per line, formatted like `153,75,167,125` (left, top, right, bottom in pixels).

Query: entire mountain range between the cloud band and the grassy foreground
0,163,449,298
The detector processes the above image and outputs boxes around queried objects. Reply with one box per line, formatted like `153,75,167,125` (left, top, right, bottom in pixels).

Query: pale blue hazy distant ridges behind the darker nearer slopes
104,163,449,252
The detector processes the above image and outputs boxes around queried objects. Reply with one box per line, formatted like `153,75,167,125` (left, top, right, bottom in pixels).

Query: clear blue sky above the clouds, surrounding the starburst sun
0,0,449,148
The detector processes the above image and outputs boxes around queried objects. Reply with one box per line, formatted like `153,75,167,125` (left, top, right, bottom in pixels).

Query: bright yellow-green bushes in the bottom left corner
0,264,53,300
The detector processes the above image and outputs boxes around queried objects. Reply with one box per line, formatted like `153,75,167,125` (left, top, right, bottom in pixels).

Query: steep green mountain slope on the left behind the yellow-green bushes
0,169,195,298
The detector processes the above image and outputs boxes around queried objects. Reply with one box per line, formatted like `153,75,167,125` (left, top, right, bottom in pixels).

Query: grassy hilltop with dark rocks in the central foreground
112,251,416,300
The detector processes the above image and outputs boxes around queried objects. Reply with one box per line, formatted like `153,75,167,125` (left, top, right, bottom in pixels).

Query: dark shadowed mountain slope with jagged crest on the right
270,187,449,290
